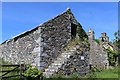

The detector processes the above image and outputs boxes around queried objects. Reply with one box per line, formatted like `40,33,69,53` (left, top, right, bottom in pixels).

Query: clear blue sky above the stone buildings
0,2,118,43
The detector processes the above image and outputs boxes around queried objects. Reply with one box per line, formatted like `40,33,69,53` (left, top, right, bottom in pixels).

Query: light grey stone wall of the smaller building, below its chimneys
90,40,109,69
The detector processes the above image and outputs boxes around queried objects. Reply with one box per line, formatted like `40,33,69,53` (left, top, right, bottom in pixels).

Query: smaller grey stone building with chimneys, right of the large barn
88,29,109,69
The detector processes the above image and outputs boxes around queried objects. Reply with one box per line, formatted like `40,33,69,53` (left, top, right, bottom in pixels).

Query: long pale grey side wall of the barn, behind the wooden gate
0,28,40,65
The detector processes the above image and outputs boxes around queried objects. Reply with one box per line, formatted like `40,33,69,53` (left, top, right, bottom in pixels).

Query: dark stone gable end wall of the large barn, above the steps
40,11,77,69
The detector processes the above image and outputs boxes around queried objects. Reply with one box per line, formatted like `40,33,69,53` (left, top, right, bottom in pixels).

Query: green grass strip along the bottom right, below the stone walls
51,67,118,80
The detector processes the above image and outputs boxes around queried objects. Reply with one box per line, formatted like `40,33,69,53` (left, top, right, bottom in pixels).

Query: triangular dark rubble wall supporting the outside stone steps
58,44,90,75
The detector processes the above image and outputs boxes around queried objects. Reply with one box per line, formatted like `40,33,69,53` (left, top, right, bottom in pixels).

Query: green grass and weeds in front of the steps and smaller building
48,67,120,80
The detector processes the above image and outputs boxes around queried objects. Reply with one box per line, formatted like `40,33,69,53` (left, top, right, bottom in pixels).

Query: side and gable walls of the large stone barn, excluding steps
0,9,85,69
